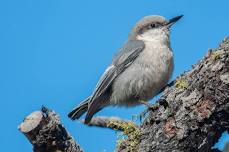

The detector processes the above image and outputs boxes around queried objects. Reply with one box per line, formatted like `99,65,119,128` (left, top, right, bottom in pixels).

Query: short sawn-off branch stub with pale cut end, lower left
19,107,83,152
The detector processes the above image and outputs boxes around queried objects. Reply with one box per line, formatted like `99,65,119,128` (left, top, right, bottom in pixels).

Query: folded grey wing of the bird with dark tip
85,40,145,123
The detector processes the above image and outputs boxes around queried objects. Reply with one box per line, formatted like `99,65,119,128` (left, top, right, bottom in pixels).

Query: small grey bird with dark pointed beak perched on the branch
68,15,182,124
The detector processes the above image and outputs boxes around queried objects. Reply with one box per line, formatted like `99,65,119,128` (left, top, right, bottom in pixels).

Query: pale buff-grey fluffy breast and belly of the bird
111,42,173,106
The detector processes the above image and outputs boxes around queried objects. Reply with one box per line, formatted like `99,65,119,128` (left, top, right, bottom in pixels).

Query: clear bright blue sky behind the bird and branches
0,0,229,152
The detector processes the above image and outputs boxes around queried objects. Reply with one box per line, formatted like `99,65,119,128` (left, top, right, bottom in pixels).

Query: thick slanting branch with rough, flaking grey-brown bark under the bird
117,38,229,152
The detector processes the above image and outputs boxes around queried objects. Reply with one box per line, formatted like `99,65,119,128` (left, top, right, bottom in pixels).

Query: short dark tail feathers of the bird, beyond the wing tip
68,97,90,120
